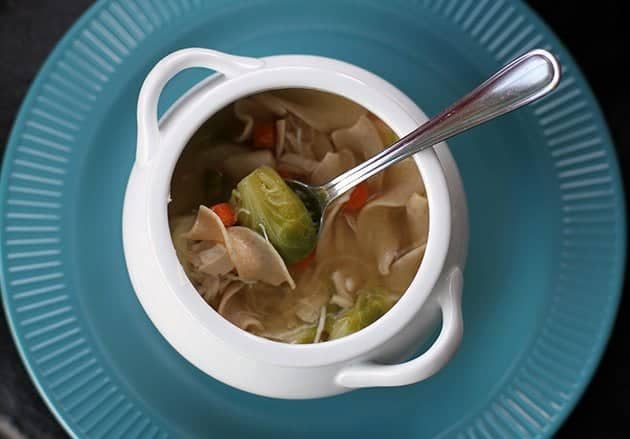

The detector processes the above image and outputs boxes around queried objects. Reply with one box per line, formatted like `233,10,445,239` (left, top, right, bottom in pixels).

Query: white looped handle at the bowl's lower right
336,267,464,389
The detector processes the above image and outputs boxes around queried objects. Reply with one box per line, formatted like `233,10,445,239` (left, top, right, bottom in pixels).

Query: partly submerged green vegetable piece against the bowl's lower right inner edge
326,288,396,340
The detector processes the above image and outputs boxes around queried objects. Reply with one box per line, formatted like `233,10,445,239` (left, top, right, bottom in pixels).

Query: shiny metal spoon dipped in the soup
287,49,560,230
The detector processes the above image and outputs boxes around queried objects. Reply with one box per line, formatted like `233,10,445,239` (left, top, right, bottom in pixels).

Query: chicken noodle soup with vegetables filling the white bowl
168,89,428,343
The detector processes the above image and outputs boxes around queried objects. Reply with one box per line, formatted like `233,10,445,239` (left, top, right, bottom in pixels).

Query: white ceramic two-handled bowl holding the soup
123,48,467,398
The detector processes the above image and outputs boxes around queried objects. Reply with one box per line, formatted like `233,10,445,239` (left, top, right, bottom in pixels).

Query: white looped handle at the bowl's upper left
136,48,264,164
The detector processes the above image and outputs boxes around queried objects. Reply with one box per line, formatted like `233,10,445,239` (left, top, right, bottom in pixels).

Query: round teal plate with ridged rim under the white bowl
0,0,626,438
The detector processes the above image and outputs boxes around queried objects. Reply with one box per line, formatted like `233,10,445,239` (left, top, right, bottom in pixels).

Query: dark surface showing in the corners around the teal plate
0,0,630,438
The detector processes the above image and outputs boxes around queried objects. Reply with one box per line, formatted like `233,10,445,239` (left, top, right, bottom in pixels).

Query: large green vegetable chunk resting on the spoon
230,166,317,264
